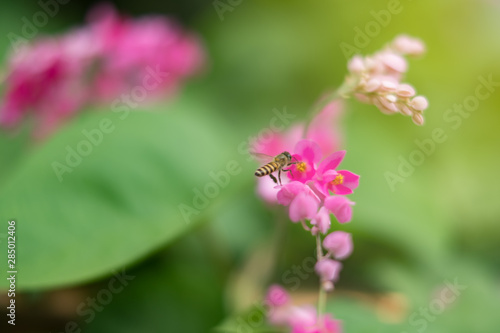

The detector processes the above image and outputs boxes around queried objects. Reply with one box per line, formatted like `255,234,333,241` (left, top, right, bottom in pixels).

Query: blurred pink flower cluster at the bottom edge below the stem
266,285,342,333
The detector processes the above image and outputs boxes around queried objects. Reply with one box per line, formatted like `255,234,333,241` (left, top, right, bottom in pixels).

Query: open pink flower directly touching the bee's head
288,140,321,183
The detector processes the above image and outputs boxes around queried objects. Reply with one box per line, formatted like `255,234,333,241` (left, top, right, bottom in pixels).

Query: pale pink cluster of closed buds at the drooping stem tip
346,35,429,125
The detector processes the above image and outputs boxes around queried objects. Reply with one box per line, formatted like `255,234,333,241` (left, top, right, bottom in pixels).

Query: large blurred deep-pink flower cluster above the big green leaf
0,5,204,137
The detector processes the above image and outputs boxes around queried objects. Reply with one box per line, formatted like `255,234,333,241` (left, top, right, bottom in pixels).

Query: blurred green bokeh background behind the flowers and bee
0,0,500,333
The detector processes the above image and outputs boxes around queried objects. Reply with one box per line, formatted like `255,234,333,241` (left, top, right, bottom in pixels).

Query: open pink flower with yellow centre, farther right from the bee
315,150,359,195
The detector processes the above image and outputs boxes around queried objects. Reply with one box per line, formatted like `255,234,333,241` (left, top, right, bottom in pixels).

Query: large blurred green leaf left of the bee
0,97,243,290
